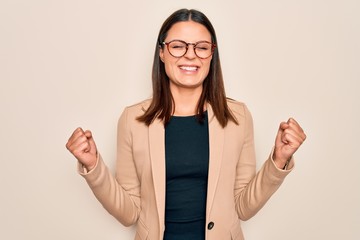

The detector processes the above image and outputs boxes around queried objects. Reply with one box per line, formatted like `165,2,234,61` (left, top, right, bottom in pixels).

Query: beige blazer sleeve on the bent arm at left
79,109,140,226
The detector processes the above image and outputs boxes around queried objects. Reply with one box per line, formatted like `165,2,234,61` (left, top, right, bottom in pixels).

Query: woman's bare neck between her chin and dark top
171,88,202,116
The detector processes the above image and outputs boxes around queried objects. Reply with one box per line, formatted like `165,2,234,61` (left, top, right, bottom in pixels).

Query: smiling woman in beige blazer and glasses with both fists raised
66,9,306,240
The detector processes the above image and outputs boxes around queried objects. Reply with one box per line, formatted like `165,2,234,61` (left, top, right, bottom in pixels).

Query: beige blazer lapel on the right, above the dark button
206,104,225,219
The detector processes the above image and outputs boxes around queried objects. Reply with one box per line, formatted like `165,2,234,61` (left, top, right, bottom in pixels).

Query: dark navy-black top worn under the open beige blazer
164,114,209,240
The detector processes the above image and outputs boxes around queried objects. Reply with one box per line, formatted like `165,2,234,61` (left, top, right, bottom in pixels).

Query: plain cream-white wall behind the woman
0,0,360,240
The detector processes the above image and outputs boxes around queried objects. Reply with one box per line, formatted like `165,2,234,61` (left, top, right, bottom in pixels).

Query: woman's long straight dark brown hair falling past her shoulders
137,9,238,127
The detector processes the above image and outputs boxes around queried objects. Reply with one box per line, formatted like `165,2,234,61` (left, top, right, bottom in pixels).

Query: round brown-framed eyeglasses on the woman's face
162,40,216,59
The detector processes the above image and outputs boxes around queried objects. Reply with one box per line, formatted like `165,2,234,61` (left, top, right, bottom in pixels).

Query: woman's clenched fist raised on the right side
273,118,306,169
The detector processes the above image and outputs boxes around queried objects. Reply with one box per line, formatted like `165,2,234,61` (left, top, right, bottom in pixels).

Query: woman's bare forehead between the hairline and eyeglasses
165,21,211,42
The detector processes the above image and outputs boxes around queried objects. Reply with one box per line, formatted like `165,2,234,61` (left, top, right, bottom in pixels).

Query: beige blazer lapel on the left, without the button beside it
149,119,166,232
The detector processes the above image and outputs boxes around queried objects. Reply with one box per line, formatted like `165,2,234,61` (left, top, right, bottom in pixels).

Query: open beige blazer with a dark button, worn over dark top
79,100,293,240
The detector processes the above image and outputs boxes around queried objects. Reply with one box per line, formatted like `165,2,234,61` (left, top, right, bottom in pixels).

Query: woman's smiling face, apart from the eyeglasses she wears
160,21,212,91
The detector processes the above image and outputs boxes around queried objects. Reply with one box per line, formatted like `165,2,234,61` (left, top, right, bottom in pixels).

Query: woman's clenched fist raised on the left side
66,128,97,171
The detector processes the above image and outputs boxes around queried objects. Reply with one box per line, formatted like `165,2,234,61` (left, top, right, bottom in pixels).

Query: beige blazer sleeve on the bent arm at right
234,105,294,220
